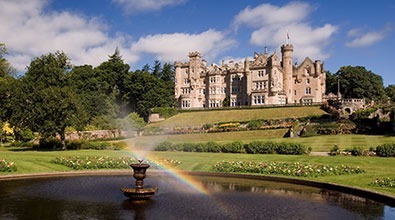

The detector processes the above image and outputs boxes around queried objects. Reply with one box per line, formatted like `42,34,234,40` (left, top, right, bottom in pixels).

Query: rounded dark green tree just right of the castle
336,66,385,100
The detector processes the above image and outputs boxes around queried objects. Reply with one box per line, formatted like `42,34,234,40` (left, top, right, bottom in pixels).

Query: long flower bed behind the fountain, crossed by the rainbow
51,156,181,170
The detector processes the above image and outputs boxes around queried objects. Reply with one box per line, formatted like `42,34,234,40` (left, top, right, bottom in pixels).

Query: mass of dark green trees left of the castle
0,44,174,147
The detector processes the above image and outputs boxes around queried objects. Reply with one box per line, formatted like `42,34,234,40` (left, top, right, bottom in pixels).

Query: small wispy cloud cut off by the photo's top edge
112,0,186,13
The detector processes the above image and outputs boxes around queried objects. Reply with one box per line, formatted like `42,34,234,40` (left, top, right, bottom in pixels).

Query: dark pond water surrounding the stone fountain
0,173,395,220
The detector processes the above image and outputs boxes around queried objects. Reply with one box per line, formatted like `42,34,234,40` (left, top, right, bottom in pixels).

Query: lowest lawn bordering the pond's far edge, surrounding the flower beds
0,150,395,196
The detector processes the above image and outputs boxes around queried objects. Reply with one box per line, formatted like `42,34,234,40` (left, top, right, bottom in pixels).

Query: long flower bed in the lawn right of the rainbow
213,161,365,177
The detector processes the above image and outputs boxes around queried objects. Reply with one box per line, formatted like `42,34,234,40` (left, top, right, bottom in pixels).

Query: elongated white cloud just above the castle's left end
130,29,236,62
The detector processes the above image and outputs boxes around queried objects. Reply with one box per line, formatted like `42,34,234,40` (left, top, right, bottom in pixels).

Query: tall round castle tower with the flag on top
281,44,294,103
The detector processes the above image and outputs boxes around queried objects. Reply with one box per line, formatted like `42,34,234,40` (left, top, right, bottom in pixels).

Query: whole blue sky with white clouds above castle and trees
0,0,395,86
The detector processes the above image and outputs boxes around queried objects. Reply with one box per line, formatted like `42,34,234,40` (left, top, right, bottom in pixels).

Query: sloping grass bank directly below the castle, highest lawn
149,106,325,127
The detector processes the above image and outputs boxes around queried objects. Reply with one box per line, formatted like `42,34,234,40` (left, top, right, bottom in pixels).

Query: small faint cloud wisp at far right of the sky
346,29,386,47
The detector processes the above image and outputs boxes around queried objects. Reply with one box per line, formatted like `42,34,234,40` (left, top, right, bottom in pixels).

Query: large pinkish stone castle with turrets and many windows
174,44,325,109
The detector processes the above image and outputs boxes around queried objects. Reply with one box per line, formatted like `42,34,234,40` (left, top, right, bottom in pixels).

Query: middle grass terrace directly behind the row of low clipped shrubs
129,129,395,152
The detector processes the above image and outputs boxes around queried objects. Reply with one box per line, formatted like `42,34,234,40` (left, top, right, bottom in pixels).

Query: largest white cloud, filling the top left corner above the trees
0,0,137,72
